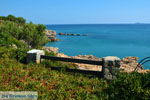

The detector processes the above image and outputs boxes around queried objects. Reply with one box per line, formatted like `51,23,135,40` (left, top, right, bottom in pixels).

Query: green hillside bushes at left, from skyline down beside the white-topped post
0,15,48,62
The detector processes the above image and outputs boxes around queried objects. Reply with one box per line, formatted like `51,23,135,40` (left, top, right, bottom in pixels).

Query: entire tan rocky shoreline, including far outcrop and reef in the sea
43,29,150,73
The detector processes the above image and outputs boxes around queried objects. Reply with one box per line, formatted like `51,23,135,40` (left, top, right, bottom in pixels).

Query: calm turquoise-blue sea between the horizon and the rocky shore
46,24,150,68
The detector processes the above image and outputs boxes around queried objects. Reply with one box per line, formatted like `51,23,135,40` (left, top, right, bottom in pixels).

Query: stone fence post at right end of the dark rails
102,56,120,80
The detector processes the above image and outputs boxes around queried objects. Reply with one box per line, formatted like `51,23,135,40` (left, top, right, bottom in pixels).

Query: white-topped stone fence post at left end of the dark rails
27,49,45,64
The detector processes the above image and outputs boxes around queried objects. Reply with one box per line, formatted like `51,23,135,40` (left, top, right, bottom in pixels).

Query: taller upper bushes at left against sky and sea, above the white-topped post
0,15,47,48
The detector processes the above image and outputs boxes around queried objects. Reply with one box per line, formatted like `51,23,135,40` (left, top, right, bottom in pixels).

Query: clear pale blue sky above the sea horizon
0,0,150,24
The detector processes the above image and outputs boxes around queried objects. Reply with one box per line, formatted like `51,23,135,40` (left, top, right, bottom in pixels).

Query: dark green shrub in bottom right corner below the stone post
107,73,150,100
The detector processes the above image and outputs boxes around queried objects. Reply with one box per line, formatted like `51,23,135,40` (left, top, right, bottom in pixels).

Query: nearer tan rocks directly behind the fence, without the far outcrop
44,47,150,73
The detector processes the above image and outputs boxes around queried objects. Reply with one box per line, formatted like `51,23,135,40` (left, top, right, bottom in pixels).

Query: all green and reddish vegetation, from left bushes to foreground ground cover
0,15,150,100
